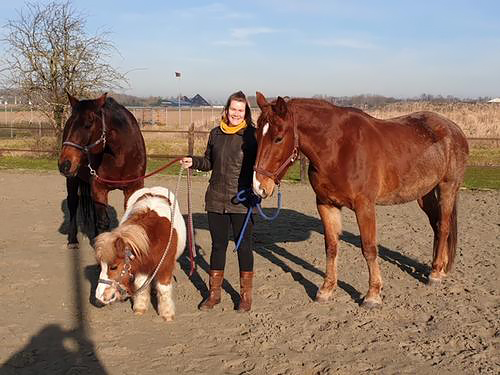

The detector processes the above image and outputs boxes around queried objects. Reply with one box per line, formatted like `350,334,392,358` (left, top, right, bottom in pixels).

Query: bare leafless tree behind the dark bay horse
1,0,127,145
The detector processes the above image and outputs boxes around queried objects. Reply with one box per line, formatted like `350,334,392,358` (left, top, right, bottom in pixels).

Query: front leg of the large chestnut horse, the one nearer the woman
316,201,342,302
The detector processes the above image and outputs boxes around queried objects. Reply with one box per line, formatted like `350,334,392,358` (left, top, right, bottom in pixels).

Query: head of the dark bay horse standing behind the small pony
58,93,106,177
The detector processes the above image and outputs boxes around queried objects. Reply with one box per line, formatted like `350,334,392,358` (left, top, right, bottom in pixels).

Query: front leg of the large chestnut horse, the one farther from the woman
354,199,382,307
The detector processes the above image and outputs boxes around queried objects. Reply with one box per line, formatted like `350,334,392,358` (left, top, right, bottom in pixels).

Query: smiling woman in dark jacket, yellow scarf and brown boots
181,91,257,312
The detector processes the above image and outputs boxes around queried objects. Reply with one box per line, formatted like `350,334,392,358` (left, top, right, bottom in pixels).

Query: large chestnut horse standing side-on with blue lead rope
253,92,469,307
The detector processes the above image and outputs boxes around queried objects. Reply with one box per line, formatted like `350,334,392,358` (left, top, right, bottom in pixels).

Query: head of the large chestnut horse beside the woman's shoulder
253,92,298,198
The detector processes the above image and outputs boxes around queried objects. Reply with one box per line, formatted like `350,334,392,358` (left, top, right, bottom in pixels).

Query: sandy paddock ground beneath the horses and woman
0,171,500,375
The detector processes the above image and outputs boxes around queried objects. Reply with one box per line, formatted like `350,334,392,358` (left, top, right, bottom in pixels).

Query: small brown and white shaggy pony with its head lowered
95,187,186,321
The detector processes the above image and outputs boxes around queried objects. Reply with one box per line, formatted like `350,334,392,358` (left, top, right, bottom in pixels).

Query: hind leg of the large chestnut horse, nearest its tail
429,181,458,284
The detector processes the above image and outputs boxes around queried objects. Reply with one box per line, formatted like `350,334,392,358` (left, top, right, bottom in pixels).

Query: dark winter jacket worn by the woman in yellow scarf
192,126,257,213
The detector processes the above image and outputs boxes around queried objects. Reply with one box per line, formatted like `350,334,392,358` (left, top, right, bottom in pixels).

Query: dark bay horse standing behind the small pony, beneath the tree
58,94,146,248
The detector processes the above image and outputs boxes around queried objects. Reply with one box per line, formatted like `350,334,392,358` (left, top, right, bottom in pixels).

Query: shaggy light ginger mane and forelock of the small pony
95,224,149,263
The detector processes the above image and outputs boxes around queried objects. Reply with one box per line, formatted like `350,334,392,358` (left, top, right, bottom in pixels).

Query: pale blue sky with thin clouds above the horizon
0,0,500,101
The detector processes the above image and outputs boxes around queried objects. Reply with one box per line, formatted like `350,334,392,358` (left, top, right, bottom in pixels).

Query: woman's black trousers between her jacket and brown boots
208,212,253,272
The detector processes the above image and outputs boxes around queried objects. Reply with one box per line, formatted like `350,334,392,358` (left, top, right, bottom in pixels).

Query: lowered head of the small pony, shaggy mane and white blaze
95,225,149,305
